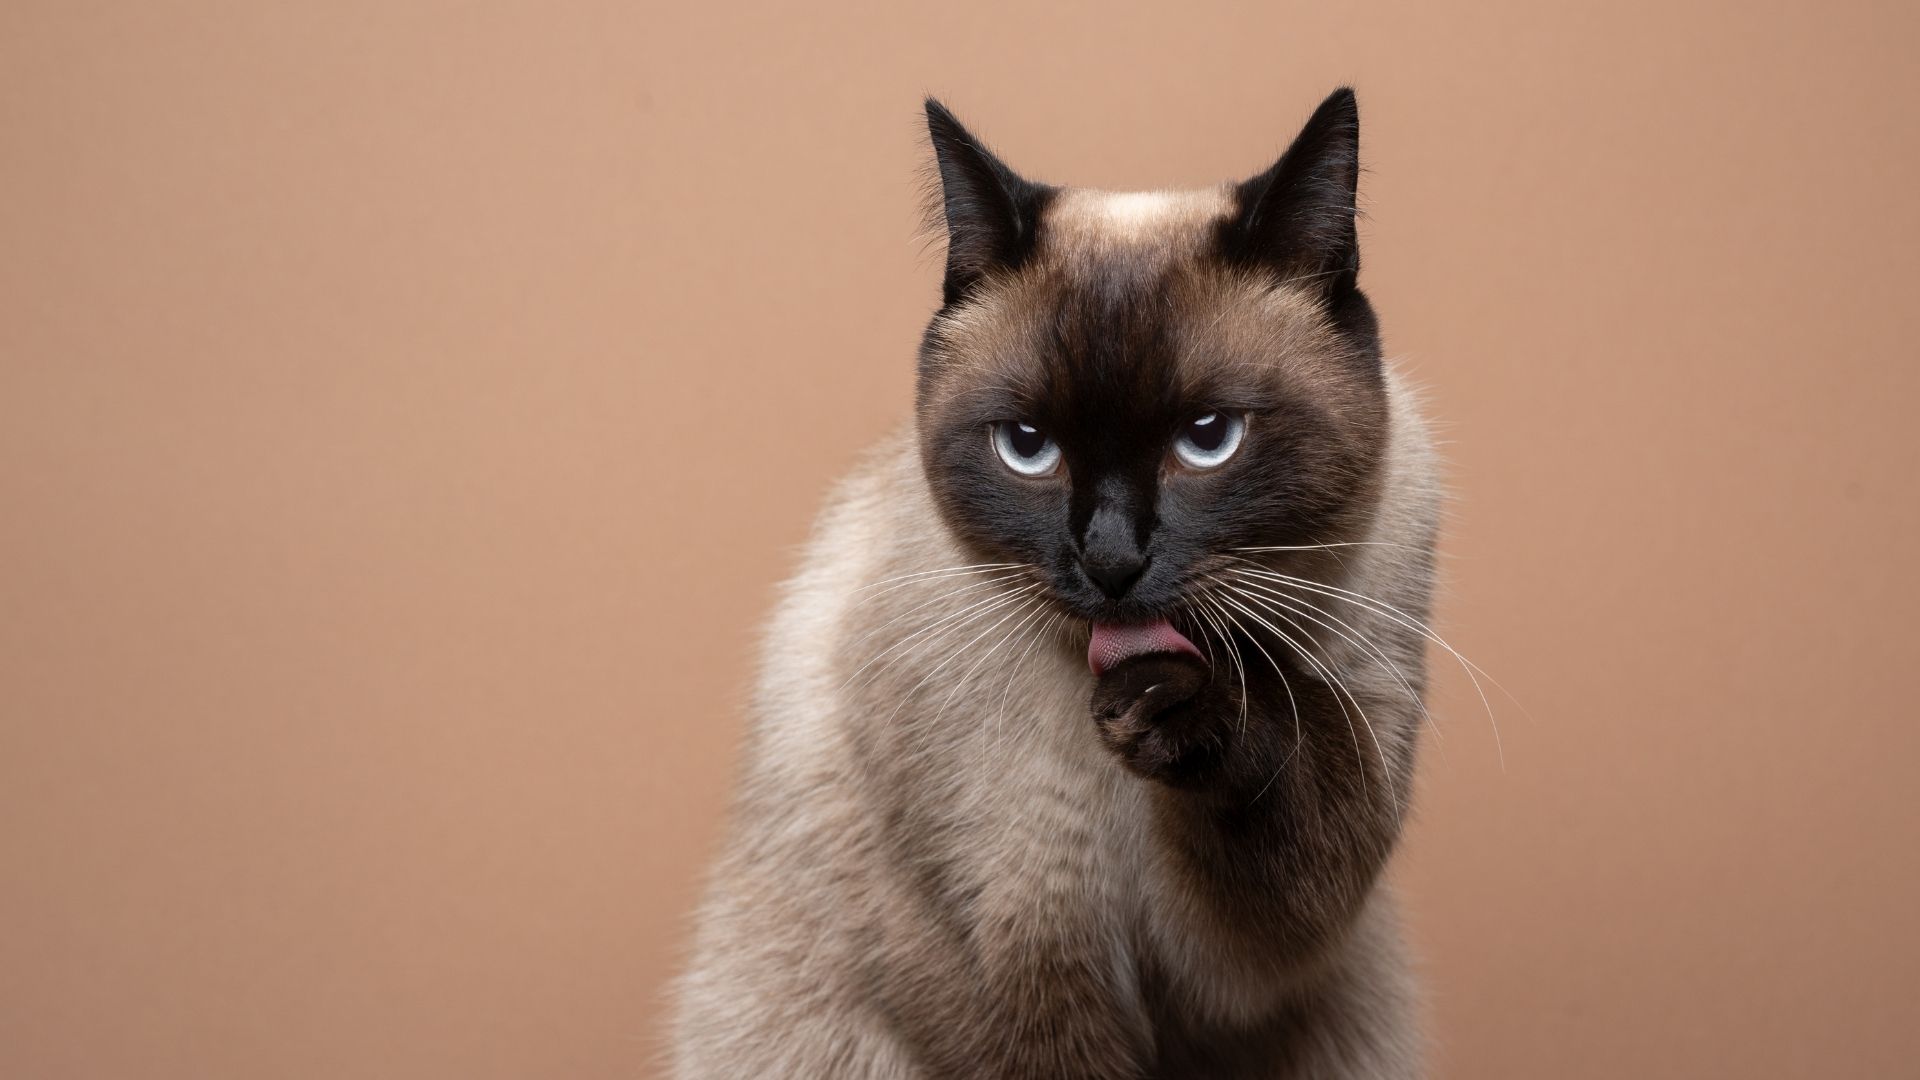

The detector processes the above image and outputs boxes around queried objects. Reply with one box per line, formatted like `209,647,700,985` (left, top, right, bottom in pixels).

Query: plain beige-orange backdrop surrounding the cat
0,0,1920,1078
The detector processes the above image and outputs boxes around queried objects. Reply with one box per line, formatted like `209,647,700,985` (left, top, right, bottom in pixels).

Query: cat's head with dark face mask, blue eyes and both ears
916,90,1388,626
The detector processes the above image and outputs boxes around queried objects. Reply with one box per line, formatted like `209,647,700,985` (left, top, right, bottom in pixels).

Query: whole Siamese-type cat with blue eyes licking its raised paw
672,88,1440,1080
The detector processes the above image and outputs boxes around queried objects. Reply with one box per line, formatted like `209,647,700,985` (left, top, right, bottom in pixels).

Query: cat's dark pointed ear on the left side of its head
927,98,1052,304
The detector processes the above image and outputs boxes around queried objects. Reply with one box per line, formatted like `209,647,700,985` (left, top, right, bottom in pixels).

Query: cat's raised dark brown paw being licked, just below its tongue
1091,653,1233,788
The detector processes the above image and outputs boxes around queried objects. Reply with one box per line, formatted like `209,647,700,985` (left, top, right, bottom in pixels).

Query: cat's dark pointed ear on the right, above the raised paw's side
1221,86,1359,306
